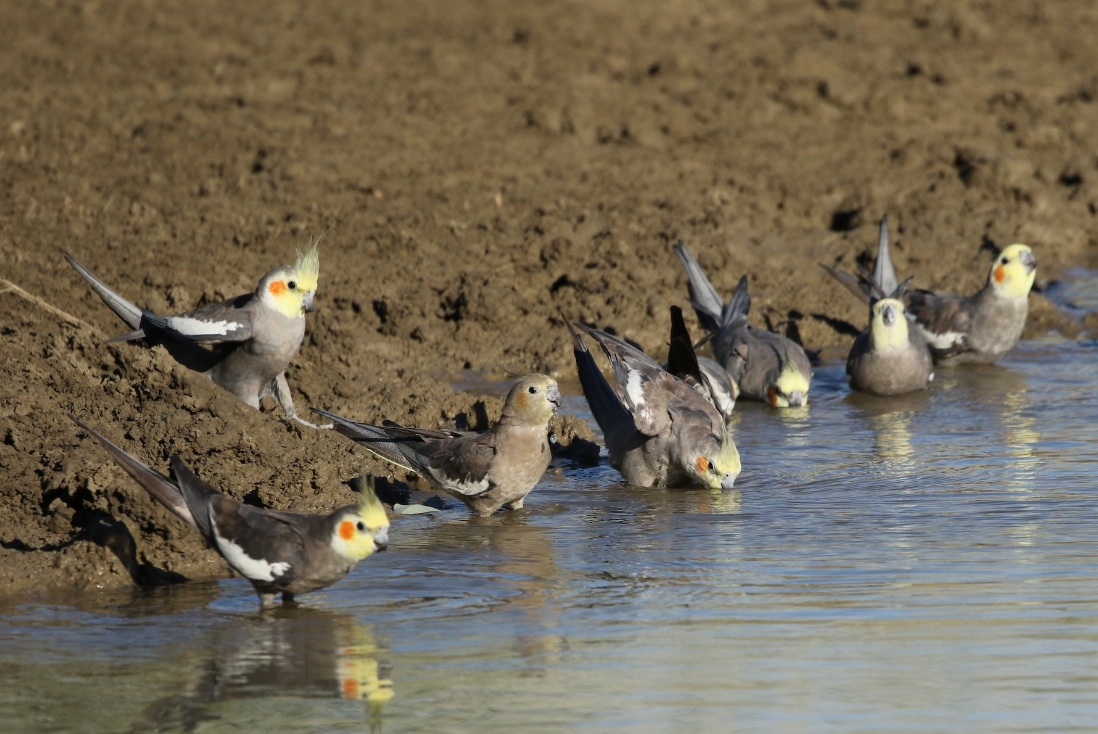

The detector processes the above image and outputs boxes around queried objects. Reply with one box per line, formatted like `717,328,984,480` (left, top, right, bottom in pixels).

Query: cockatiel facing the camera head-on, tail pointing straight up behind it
824,215,934,396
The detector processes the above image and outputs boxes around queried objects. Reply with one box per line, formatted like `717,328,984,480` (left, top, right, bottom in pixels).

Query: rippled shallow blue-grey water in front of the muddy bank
0,341,1098,732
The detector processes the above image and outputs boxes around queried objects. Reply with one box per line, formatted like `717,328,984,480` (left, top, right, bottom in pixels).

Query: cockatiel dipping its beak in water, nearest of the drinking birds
565,320,740,489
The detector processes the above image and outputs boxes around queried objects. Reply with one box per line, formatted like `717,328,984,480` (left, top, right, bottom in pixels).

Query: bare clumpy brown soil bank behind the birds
0,0,1098,593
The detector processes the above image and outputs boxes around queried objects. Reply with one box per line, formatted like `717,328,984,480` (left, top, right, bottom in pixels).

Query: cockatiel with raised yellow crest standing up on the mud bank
65,244,332,429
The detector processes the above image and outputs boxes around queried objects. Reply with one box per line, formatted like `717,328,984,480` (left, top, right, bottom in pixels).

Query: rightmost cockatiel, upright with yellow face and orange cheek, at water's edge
828,217,1037,366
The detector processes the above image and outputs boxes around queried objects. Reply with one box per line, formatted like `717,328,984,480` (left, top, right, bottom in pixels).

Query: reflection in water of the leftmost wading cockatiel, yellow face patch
132,607,393,732
